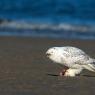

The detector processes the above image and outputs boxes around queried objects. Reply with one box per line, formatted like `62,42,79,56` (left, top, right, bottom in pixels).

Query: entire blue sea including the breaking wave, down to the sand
0,0,95,39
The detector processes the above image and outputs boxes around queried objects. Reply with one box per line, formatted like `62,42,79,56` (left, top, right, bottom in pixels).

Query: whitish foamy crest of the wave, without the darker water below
0,20,95,32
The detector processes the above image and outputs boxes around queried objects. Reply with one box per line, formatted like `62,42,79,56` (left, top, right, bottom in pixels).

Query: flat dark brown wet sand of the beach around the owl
0,37,95,95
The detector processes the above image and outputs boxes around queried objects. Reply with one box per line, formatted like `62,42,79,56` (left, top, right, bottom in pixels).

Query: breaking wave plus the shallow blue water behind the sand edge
0,20,95,40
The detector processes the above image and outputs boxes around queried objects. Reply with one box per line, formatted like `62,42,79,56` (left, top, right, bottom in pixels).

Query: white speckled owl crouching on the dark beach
46,46,95,77
